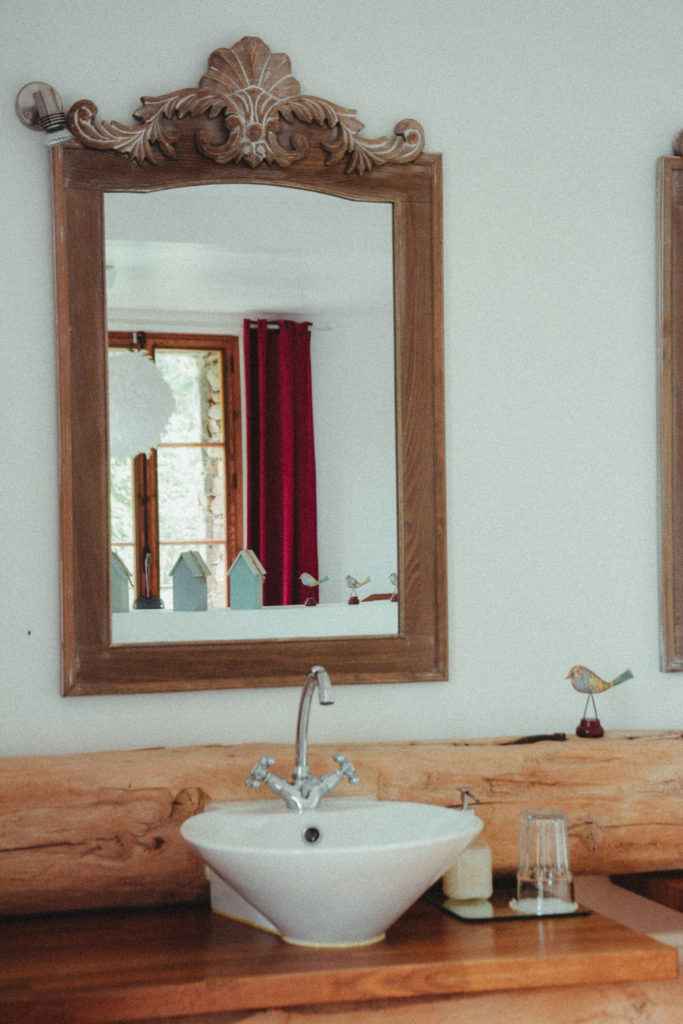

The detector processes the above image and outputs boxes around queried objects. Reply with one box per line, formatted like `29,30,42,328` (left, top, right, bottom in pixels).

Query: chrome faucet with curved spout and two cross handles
245,665,360,811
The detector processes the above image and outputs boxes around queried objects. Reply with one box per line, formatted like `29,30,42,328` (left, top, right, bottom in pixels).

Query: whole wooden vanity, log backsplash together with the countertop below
0,732,683,1024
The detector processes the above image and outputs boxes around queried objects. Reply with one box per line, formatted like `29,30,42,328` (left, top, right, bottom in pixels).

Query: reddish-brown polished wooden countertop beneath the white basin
0,900,677,1024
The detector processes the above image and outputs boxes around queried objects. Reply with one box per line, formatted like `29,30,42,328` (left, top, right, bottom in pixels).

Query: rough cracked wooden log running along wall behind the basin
0,731,683,914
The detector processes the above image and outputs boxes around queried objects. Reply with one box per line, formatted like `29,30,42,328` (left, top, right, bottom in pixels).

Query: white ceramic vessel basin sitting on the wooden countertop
180,798,482,946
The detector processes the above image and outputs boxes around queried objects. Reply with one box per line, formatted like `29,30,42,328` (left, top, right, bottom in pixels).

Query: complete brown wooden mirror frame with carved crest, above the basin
45,37,447,695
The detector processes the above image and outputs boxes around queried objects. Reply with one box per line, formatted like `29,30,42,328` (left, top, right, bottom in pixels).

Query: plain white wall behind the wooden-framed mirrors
0,0,683,754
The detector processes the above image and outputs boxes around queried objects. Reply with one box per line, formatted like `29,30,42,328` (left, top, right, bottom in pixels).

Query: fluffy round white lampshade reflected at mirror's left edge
109,349,175,459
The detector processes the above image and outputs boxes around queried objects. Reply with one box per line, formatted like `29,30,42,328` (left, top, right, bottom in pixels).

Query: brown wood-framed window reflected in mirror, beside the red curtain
109,332,243,608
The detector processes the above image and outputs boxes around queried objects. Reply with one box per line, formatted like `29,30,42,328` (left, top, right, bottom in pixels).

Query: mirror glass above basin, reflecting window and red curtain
104,184,397,643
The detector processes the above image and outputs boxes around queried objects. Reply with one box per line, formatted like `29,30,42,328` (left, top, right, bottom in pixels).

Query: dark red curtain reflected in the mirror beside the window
243,319,317,605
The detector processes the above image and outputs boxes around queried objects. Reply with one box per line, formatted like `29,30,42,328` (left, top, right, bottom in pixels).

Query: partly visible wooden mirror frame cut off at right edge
657,132,683,672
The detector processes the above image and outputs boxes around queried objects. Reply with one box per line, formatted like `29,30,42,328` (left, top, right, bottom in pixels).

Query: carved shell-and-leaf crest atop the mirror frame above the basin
69,36,424,174
